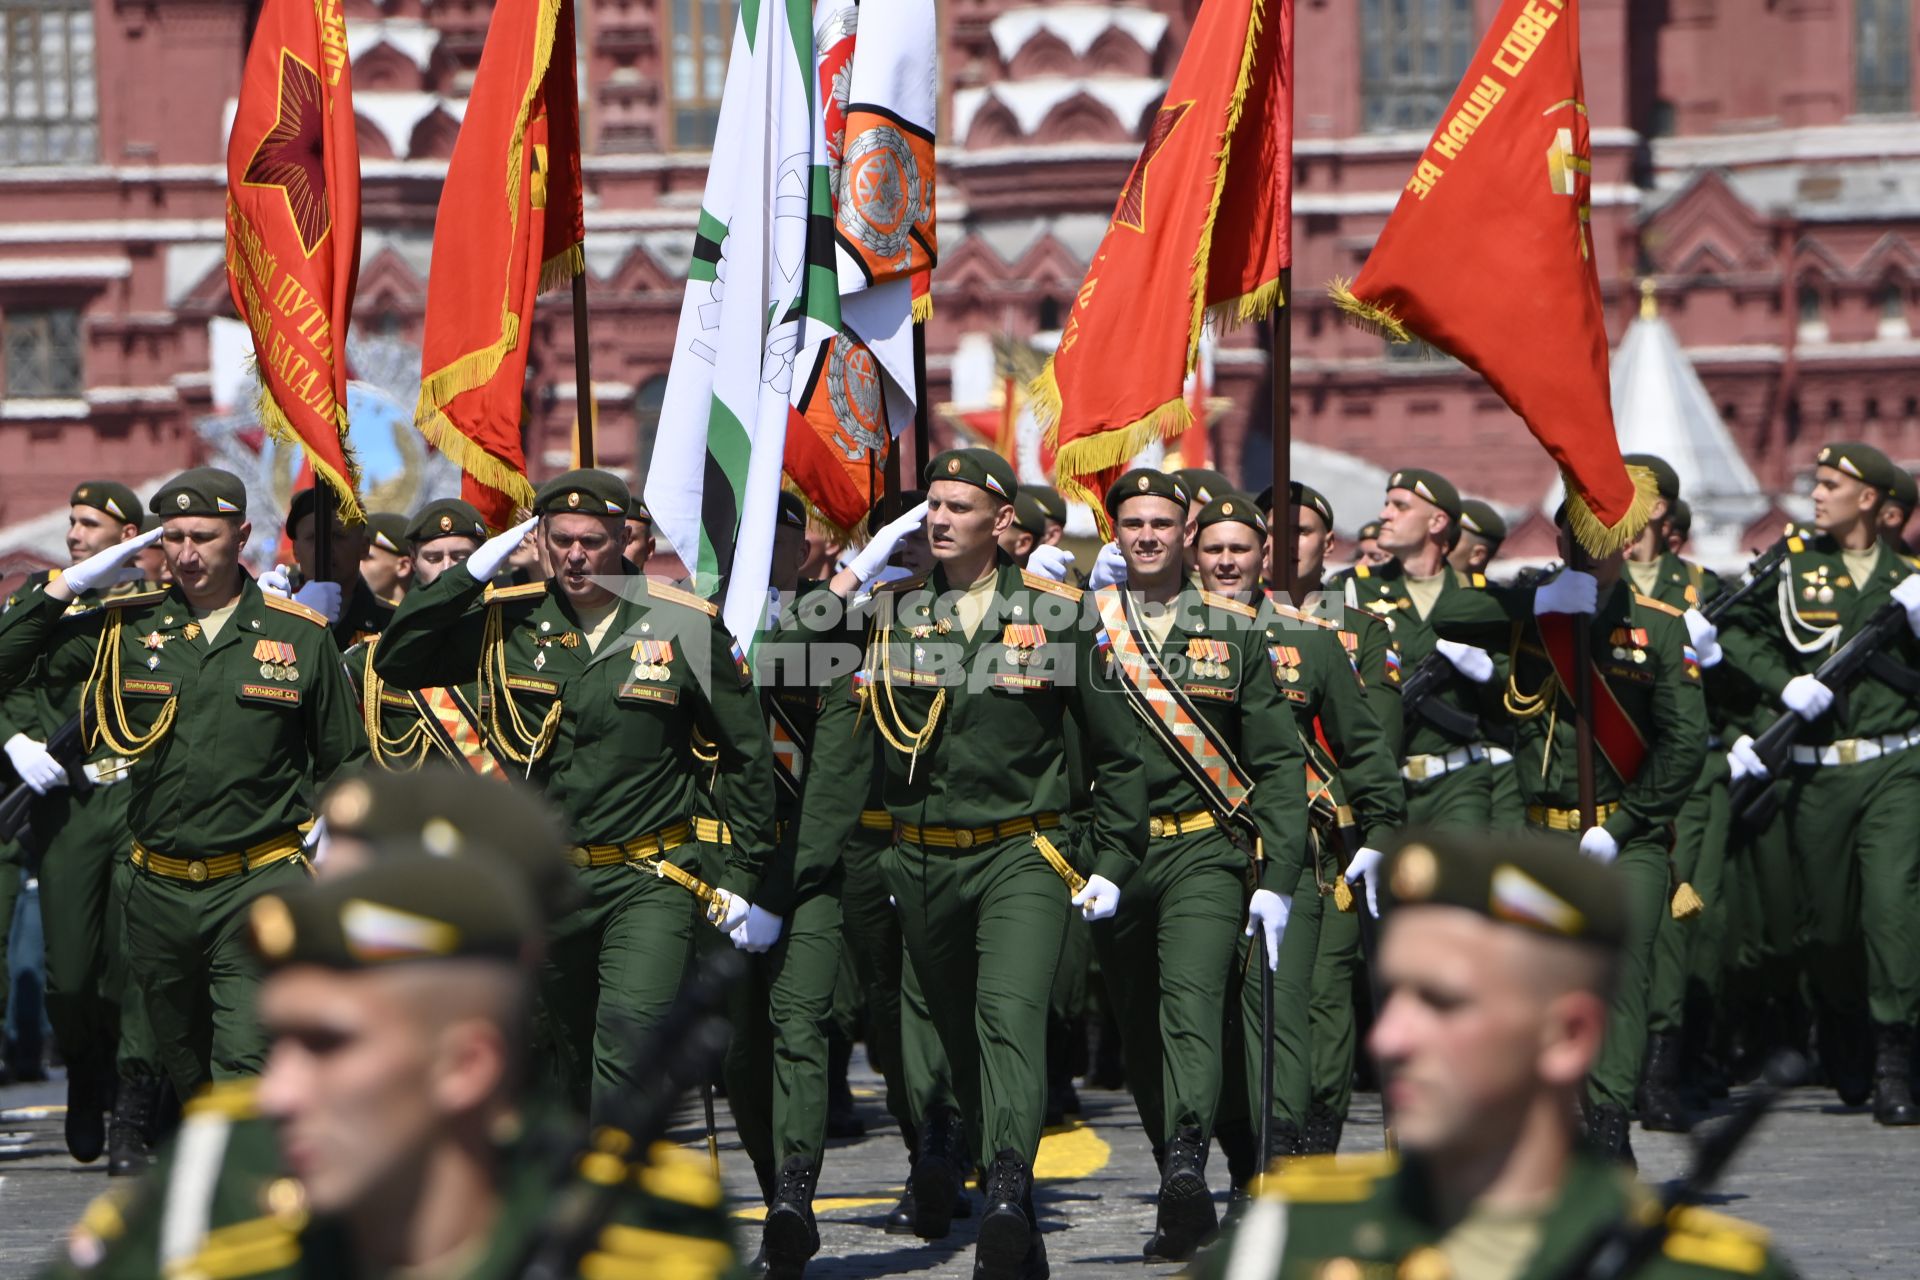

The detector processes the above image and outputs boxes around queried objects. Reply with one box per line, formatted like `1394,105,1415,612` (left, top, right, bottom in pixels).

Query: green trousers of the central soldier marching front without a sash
883,835,1069,1165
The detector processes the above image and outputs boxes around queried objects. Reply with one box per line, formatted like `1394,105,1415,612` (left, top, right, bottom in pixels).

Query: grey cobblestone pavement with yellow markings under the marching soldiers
0,1059,1920,1280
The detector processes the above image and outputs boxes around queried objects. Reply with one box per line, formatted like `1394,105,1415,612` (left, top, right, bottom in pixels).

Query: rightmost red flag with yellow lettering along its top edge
1332,0,1653,555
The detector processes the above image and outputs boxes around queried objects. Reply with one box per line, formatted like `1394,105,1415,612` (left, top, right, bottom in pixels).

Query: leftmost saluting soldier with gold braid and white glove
0,468,367,1098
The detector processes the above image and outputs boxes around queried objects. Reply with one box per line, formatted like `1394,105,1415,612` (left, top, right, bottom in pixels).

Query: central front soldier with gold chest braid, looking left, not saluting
822,449,1146,1280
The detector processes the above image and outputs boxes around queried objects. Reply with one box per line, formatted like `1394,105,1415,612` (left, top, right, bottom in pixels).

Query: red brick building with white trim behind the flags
0,0,1920,574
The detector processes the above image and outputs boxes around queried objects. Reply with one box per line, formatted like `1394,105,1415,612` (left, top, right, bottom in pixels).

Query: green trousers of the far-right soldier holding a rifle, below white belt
1788,748,1920,1027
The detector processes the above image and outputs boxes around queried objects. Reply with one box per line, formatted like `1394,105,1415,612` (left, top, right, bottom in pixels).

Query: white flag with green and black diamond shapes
647,0,814,647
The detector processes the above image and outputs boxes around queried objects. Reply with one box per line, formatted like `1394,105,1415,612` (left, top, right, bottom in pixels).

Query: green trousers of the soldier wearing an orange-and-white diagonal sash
1092,829,1246,1146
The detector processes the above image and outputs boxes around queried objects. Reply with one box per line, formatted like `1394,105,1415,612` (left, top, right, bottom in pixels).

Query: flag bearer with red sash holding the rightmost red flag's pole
1430,505,1707,1163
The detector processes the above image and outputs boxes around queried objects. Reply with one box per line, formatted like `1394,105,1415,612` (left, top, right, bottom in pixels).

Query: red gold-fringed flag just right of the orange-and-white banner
1033,0,1292,520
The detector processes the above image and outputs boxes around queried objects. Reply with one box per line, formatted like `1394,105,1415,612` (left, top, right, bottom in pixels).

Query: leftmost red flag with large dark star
227,0,365,522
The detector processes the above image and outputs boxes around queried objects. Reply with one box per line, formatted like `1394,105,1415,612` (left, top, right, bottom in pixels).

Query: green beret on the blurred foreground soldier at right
1380,829,1628,948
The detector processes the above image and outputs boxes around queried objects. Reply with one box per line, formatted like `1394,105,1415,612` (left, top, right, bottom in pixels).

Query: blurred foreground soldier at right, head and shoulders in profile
1200,831,1789,1280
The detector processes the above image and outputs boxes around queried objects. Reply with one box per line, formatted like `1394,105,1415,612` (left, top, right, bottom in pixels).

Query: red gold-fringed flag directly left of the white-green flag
415,0,586,530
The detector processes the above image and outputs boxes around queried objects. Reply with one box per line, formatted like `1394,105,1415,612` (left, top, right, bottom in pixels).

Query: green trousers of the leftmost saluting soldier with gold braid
127,854,313,1098
